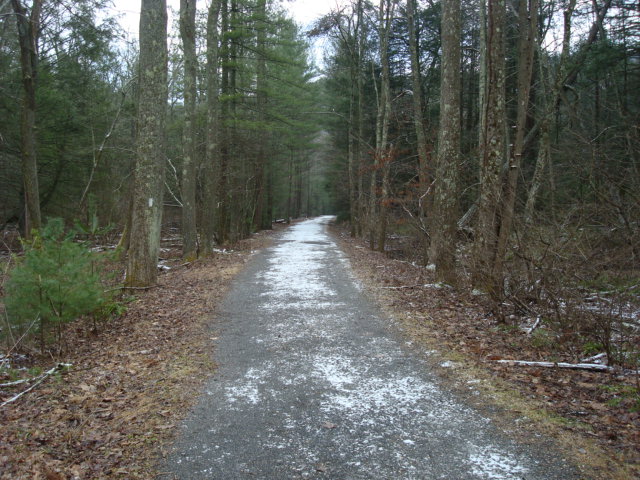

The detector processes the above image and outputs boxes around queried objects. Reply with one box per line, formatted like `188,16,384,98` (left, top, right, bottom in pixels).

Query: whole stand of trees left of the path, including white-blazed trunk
0,0,324,286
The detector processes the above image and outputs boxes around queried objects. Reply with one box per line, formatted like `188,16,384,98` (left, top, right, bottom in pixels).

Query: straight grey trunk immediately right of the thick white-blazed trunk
180,0,198,261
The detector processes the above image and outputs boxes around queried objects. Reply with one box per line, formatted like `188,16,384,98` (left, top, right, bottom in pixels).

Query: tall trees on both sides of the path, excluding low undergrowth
0,0,640,305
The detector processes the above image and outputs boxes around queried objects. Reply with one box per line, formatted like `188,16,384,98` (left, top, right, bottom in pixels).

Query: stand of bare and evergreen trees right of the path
320,0,640,322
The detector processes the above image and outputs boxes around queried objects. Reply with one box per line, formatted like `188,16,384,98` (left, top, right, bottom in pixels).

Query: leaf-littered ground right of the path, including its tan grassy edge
334,227,640,479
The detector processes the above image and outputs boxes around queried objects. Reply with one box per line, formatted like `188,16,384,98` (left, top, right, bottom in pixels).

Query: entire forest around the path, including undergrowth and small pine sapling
0,0,640,476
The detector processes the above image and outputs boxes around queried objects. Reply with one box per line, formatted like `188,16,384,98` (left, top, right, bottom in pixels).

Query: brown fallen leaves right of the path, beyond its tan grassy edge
337,225,640,473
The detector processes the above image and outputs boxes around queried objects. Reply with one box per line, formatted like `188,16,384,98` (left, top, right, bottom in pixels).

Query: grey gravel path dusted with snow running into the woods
167,217,580,480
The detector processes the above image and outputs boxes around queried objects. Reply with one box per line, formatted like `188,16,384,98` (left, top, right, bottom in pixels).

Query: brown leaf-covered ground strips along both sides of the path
0,221,640,480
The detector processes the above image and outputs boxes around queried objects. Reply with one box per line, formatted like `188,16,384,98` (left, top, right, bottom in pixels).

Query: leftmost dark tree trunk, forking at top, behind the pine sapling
11,0,42,238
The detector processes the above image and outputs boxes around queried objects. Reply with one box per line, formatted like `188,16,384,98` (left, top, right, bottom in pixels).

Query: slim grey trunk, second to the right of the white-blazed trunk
200,0,222,256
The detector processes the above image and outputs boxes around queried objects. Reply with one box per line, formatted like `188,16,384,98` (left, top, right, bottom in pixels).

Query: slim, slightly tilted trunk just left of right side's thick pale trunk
407,0,430,263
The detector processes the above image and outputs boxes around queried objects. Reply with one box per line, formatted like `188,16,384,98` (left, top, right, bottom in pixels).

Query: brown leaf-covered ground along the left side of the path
0,226,282,480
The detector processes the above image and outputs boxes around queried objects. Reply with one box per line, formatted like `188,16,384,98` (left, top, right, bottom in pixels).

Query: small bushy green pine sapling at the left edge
5,218,105,351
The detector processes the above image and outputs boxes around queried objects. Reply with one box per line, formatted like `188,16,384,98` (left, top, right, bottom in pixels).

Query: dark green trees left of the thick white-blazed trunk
0,0,133,234
